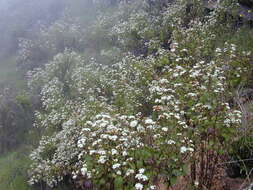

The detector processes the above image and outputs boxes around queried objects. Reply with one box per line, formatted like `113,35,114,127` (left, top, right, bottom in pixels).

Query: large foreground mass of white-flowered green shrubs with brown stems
29,0,250,190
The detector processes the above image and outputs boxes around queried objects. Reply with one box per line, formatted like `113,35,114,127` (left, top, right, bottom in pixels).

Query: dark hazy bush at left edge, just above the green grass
0,88,33,153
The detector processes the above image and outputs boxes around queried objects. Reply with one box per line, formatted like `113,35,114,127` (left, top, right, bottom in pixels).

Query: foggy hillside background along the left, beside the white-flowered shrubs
0,0,95,190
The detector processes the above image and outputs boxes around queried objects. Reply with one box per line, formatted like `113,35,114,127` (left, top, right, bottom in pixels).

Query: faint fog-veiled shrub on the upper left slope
18,19,84,71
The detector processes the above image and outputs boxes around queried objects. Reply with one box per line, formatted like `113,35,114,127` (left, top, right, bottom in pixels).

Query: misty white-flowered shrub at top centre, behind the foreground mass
89,0,174,55
